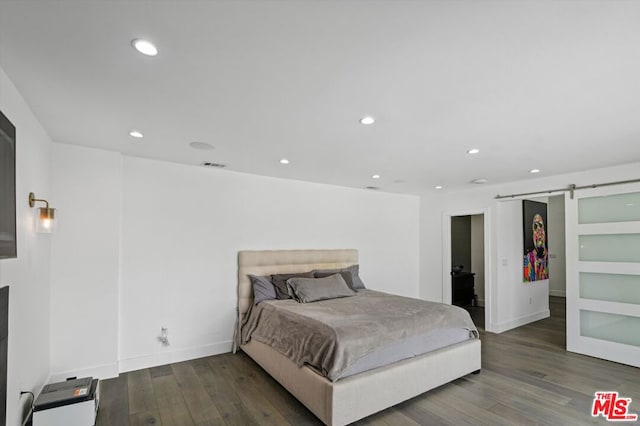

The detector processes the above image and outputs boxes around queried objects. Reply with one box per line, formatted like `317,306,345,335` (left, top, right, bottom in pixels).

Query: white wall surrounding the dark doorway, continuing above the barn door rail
420,163,640,331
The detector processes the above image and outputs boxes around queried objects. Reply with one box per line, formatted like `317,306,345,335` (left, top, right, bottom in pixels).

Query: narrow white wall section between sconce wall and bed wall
51,143,122,380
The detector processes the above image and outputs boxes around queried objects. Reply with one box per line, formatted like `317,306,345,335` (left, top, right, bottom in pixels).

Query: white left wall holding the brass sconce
0,68,56,426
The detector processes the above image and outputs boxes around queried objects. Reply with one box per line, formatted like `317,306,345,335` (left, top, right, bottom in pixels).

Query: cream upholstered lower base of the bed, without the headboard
241,339,481,426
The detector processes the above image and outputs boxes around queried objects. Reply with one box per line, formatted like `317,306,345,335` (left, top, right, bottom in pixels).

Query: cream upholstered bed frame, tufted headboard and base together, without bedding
234,250,480,426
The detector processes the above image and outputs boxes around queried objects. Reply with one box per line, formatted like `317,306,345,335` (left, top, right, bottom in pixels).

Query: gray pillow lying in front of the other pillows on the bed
287,274,356,303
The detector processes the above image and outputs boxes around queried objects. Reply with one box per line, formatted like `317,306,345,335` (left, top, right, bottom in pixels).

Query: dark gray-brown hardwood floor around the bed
97,297,640,426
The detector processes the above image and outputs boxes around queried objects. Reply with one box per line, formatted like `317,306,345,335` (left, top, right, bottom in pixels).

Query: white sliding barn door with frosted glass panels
565,184,640,367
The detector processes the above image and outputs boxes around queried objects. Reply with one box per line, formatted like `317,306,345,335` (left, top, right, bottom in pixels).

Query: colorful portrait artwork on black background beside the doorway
522,200,549,282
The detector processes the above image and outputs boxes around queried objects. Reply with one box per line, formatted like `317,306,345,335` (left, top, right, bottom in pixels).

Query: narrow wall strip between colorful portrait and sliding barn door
547,195,567,297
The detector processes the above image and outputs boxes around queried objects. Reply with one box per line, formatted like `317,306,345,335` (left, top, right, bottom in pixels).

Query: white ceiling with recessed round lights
0,0,640,193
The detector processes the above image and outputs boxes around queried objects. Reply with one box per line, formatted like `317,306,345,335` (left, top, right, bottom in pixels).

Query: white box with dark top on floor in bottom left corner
33,377,99,426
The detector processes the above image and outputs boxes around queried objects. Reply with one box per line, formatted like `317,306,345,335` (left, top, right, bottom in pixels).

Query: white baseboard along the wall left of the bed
119,340,232,373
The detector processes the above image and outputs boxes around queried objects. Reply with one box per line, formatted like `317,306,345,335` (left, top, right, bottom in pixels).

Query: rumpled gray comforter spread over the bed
242,290,478,381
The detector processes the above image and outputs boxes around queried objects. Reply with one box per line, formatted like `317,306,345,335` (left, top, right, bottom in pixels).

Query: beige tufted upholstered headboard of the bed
234,249,358,352
